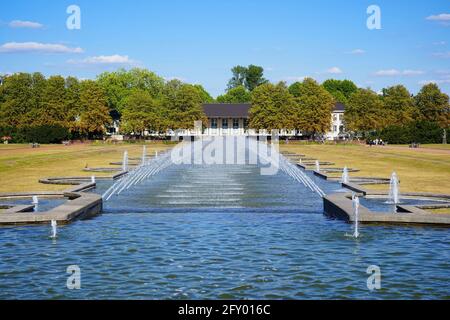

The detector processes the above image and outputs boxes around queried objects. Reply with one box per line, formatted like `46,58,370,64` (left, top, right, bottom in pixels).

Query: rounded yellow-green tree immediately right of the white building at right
344,89,386,134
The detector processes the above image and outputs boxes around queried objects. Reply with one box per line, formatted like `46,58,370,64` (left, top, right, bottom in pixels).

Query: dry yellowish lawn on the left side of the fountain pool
0,143,170,192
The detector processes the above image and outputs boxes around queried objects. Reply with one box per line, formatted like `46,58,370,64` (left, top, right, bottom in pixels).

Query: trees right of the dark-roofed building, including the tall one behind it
217,65,450,140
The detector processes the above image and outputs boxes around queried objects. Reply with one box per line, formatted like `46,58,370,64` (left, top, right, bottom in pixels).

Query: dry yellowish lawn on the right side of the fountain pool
280,142,450,194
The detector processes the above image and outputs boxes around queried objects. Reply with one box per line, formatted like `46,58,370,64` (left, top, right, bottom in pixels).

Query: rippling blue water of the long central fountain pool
0,165,450,299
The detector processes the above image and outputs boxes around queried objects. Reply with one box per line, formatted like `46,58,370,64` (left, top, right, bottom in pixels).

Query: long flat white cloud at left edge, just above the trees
0,42,83,53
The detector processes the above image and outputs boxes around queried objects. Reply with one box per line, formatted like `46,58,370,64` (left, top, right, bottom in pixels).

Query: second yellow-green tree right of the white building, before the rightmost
383,85,417,125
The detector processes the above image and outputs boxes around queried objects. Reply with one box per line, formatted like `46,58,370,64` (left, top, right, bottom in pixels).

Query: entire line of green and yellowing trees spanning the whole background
0,65,450,140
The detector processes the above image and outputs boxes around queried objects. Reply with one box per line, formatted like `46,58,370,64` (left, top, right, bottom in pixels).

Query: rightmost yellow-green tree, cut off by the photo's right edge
415,83,450,128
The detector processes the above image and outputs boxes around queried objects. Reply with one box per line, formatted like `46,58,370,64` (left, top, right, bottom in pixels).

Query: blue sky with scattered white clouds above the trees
0,0,450,96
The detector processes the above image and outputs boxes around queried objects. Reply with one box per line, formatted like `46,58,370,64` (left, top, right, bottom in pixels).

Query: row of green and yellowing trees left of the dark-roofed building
0,69,213,141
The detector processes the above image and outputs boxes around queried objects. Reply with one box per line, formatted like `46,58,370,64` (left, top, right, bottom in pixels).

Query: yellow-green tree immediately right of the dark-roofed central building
250,83,295,130
